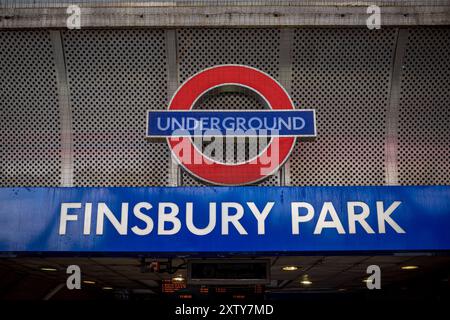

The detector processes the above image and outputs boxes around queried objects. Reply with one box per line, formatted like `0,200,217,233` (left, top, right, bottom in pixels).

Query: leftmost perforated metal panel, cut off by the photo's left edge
0,31,61,187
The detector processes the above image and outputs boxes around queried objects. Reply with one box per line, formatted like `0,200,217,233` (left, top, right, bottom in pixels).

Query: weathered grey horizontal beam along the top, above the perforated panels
0,1,450,29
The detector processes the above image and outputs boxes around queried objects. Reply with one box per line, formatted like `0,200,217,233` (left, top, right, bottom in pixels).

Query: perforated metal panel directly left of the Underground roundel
63,30,169,186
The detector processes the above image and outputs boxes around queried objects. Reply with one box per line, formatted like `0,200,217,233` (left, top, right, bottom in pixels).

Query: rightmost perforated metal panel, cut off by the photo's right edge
398,29,450,185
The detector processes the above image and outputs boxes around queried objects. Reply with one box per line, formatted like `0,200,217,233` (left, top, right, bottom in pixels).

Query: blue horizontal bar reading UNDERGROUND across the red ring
146,110,316,138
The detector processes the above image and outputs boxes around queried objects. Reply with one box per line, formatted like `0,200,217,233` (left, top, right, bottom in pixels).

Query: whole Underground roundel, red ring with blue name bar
147,65,316,185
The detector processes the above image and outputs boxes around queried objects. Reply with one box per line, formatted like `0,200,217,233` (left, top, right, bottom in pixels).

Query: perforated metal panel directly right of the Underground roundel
290,28,396,185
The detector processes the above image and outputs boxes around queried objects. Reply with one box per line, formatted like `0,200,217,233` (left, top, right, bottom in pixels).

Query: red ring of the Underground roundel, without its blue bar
167,65,296,185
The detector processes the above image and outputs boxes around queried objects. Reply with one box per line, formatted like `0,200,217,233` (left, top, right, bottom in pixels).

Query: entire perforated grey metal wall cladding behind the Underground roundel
0,28,450,186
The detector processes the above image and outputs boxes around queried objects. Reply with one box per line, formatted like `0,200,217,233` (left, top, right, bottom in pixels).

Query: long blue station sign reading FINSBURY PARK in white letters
0,186,450,253
